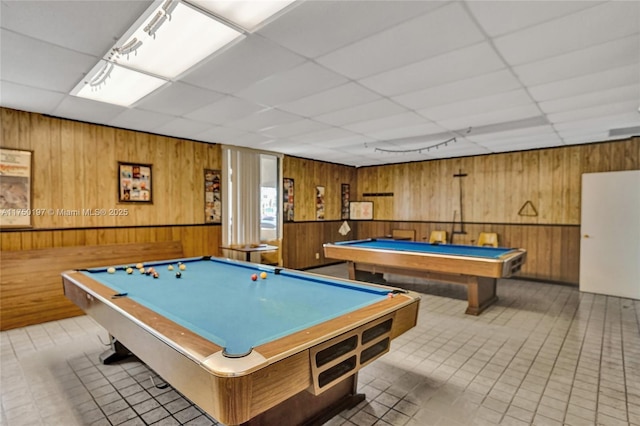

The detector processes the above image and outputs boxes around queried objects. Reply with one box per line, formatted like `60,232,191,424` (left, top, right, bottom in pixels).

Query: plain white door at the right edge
580,170,640,299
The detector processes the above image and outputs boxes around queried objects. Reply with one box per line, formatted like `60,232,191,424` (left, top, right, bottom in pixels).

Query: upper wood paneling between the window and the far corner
282,157,357,222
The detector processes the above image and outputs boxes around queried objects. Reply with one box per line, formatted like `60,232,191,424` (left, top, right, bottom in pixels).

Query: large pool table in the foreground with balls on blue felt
62,254,419,425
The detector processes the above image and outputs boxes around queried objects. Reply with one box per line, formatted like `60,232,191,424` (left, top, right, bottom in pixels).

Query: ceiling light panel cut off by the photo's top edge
188,0,295,32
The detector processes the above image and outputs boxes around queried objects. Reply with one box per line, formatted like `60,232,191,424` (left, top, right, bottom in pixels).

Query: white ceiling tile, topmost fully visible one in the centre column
317,3,484,79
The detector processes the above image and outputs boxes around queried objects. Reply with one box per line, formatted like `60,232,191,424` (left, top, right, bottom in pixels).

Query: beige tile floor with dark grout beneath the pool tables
0,265,640,426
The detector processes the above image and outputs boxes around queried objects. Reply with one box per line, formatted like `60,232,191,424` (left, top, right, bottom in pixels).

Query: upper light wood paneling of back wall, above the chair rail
354,138,640,225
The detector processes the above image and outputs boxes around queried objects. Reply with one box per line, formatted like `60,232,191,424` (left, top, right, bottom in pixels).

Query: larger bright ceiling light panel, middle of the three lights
110,0,243,79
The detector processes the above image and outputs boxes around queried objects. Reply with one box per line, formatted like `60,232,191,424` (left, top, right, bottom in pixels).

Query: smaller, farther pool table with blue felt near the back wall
324,239,527,315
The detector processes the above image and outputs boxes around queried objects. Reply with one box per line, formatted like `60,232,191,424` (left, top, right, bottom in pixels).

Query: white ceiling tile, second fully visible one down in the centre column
361,43,505,96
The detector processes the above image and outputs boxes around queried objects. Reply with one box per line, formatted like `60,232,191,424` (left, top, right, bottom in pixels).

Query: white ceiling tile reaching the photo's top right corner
495,2,640,65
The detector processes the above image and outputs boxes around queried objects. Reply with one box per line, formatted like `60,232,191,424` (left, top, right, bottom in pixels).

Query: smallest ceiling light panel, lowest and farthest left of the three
71,60,167,106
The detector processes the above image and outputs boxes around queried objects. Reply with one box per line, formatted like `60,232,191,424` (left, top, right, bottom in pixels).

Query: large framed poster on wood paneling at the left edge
0,148,33,228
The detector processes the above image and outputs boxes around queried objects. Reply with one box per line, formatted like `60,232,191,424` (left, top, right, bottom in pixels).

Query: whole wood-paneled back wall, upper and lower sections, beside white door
357,137,640,284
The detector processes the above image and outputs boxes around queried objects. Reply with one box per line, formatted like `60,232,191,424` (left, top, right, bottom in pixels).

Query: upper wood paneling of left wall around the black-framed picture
0,108,222,228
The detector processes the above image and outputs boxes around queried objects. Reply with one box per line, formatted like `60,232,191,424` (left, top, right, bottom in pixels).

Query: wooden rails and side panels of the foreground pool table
63,264,419,425
